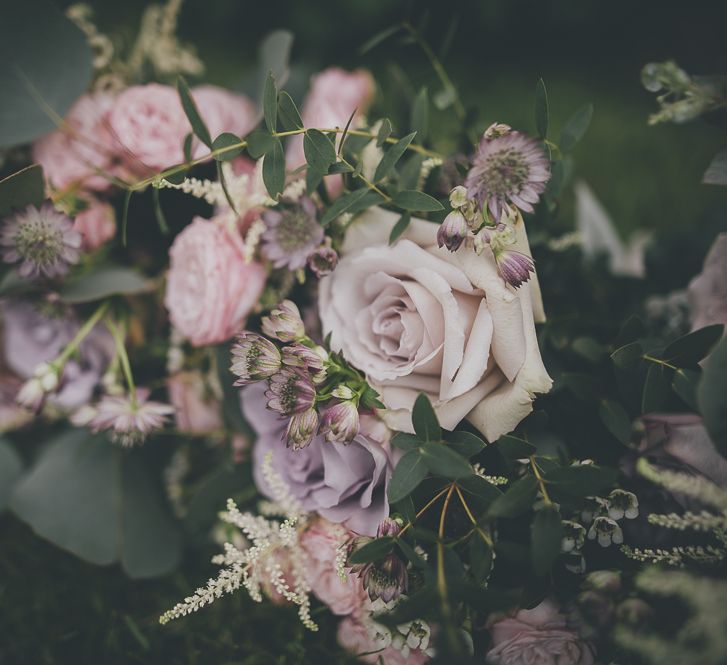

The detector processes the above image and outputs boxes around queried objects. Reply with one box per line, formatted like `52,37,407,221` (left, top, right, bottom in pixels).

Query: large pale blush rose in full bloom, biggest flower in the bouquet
318,208,552,441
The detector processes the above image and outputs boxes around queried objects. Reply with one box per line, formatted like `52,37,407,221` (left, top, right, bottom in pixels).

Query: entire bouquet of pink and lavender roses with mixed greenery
0,0,727,665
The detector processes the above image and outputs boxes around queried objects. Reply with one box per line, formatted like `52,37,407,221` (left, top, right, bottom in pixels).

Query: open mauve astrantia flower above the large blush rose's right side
465,132,550,221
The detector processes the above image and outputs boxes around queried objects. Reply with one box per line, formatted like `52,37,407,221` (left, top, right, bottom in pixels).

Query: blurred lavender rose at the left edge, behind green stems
1,301,115,410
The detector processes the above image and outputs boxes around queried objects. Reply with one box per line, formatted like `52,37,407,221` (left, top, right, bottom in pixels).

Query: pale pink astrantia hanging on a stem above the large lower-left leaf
89,389,174,446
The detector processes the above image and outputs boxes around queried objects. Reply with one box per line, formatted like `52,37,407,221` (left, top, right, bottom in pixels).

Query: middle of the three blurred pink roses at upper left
109,83,196,173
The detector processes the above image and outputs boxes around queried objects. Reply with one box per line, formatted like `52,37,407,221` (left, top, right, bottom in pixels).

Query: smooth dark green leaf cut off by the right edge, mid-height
697,337,727,457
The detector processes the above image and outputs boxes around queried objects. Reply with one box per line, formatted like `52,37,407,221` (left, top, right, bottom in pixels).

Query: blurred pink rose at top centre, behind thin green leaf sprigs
287,67,375,169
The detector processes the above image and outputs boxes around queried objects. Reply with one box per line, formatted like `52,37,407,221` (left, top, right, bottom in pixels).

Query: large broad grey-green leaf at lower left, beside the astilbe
12,430,181,578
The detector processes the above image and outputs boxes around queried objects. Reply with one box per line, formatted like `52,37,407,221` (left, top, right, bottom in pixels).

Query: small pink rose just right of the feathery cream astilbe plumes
300,519,365,615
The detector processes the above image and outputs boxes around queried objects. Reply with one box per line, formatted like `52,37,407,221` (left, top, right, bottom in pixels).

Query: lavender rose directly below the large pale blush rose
241,383,395,536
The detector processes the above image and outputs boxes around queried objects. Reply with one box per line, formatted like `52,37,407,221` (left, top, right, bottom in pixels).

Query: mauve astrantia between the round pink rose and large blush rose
263,198,323,270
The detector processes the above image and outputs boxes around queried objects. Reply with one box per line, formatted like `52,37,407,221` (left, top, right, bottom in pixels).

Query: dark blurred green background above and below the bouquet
5,0,727,665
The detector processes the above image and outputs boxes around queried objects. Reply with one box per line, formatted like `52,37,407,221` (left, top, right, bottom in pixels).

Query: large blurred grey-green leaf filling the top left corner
0,0,93,148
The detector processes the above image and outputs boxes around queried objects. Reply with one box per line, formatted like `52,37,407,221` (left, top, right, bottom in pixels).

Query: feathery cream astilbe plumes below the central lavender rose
159,453,318,631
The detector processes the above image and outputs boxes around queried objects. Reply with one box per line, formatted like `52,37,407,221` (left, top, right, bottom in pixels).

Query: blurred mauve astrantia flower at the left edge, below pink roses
0,203,82,278
